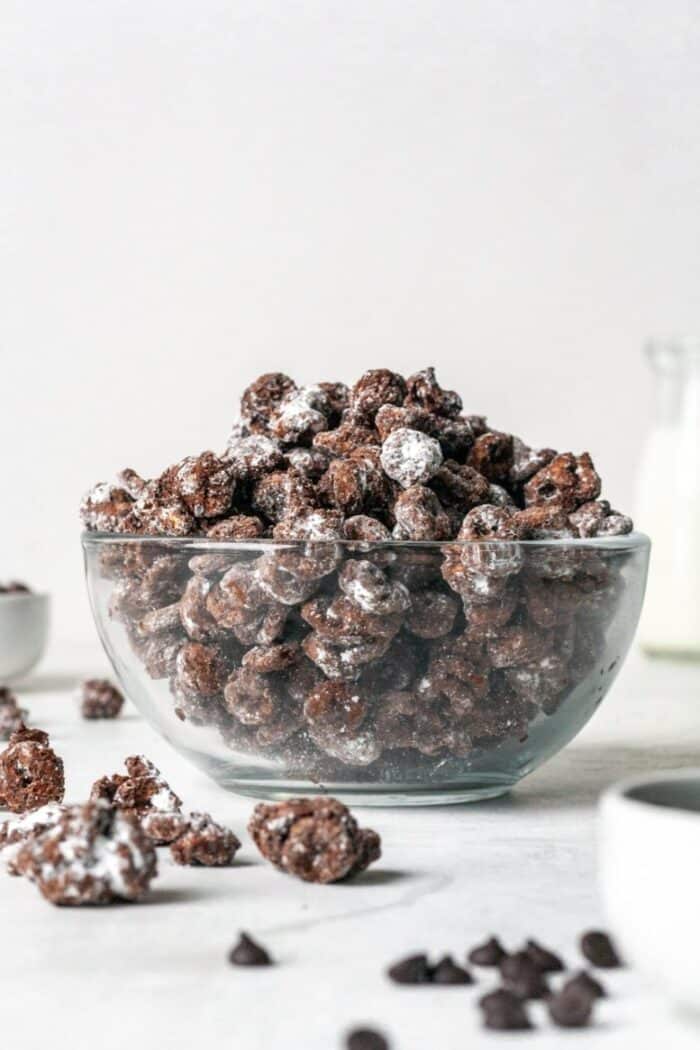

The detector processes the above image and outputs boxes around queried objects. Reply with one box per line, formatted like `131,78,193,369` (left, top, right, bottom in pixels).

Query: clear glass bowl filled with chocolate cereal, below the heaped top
83,532,650,805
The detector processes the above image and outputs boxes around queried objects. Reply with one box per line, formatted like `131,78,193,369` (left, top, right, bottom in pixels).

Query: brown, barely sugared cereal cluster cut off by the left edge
0,723,65,813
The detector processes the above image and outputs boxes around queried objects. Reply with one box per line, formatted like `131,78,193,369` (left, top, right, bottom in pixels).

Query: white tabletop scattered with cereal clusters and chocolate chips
0,647,700,1050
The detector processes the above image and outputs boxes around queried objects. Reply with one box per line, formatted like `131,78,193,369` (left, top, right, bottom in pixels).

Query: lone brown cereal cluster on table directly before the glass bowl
248,798,381,883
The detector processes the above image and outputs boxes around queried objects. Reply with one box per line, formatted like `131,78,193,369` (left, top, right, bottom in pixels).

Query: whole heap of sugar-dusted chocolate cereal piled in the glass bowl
82,369,632,780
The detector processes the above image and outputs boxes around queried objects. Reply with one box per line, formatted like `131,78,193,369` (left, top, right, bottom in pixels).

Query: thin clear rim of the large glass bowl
81,531,651,553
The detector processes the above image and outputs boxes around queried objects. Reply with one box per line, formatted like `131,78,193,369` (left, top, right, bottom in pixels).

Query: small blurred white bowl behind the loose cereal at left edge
0,593,49,685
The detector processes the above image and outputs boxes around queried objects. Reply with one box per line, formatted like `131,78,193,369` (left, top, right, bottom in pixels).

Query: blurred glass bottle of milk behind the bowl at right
636,338,700,659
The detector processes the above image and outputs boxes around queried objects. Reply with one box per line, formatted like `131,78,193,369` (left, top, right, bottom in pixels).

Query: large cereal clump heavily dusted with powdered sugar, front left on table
16,801,156,905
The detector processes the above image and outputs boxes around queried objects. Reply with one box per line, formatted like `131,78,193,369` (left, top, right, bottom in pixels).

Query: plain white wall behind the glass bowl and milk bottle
0,0,700,641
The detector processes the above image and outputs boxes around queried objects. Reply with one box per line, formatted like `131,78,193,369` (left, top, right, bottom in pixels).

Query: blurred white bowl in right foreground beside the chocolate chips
600,769,700,1011
